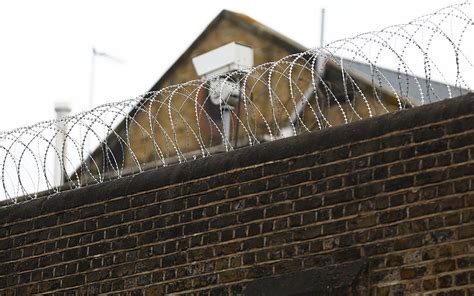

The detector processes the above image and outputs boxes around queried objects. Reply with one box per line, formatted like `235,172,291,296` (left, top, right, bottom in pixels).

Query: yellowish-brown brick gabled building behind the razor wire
76,10,467,181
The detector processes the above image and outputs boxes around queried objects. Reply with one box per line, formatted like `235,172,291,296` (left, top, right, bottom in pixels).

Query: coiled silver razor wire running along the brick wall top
0,2,474,202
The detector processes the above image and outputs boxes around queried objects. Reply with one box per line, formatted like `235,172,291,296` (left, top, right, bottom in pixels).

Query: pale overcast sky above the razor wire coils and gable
0,0,473,131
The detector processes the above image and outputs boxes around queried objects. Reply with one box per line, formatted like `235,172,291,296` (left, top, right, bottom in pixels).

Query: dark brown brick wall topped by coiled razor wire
0,94,474,295
